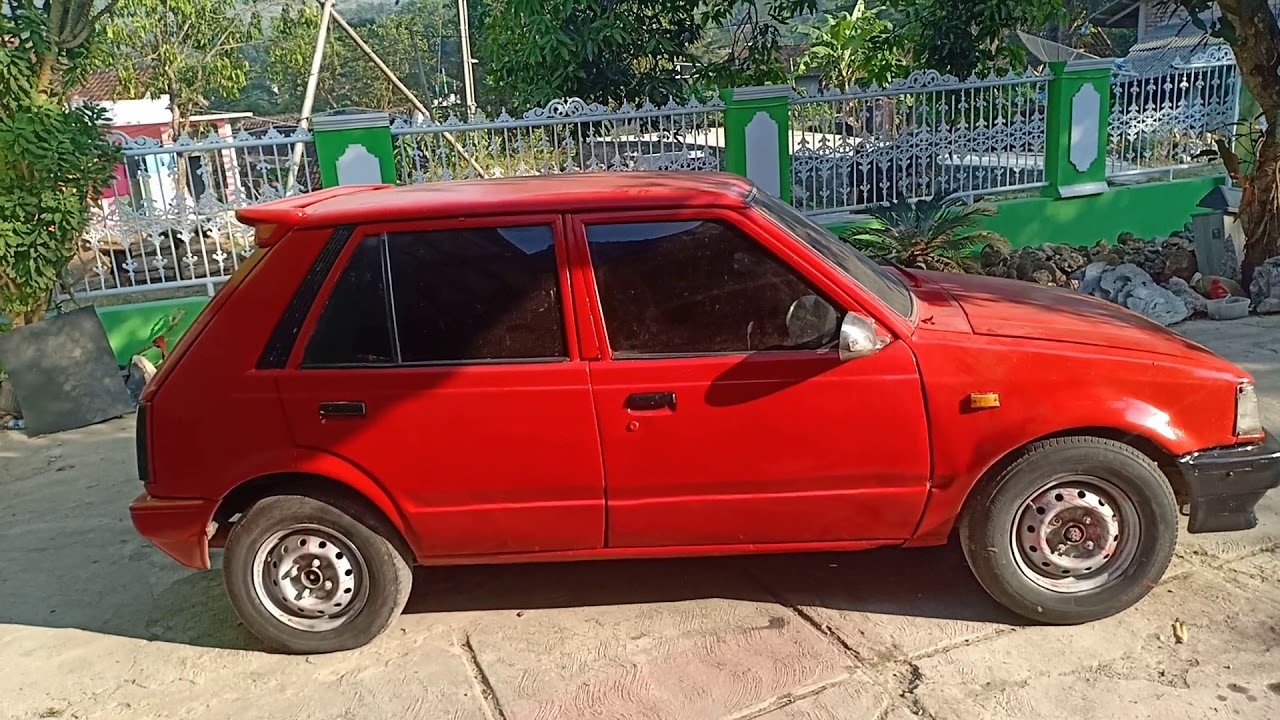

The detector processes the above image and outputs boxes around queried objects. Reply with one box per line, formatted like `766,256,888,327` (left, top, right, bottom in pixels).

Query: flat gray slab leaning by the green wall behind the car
0,307,133,437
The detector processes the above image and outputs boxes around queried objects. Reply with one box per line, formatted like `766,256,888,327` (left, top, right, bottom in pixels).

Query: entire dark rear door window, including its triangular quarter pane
305,225,567,366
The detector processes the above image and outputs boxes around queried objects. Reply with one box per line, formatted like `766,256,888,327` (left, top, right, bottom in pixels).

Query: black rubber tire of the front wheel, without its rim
959,437,1178,625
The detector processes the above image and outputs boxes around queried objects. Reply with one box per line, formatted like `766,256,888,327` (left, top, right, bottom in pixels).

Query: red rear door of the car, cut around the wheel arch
279,217,604,556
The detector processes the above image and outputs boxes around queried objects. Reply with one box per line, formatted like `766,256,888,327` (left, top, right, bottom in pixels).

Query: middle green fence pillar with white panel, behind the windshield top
721,86,791,202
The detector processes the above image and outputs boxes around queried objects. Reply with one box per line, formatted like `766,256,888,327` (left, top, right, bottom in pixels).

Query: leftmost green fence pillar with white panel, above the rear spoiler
311,113,396,187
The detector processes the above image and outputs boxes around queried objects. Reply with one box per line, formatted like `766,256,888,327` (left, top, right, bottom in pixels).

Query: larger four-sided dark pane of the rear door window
387,227,566,363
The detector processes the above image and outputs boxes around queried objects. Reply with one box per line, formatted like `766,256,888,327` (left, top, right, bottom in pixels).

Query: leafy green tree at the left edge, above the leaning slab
0,0,119,327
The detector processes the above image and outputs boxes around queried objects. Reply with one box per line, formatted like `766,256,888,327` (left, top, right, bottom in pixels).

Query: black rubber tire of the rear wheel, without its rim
223,496,413,653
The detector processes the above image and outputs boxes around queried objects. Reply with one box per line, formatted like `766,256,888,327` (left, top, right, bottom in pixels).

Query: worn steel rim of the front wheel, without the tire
1010,475,1142,594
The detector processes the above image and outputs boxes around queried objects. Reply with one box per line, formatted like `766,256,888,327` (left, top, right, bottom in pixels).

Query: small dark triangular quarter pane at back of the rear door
302,236,393,365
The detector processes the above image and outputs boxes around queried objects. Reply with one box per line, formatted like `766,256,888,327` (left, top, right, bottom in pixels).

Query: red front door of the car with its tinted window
573,209,929,547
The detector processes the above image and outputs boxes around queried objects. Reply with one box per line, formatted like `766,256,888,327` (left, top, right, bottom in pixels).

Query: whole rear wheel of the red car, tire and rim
223,496,412,653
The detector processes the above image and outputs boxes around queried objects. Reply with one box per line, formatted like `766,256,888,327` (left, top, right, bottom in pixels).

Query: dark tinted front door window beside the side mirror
586,220,829,355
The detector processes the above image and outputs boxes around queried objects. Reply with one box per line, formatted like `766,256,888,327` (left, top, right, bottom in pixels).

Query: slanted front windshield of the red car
751,191,915,318
